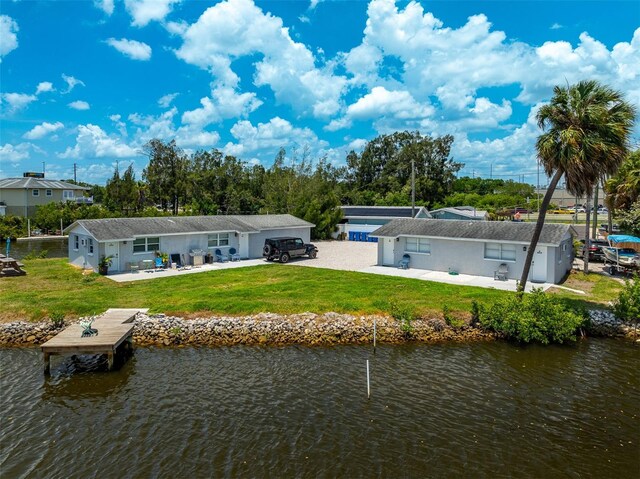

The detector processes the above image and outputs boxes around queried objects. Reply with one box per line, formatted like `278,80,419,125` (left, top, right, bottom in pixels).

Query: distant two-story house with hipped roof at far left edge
0,173,93,218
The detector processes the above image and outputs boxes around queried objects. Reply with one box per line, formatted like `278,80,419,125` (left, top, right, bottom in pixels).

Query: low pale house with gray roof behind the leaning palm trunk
371,219,575,283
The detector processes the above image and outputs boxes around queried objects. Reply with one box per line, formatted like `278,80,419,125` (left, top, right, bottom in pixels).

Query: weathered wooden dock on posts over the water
40,308,148,374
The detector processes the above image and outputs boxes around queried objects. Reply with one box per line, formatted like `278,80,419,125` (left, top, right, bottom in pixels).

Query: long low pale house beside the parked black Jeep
65,214,315,272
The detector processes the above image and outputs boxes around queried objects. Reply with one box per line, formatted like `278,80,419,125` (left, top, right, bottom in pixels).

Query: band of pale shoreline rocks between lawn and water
0,310,636,346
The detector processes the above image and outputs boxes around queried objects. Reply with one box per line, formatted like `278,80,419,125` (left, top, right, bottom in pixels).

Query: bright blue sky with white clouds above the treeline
0,0,640,184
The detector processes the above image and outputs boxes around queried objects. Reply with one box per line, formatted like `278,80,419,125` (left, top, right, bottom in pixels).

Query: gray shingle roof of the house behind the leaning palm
369,218,573,246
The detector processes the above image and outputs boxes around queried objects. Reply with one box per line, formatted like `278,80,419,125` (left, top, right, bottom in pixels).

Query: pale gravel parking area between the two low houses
289,241,378,271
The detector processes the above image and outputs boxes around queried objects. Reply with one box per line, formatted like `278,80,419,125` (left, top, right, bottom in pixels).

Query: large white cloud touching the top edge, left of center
176,0,346,117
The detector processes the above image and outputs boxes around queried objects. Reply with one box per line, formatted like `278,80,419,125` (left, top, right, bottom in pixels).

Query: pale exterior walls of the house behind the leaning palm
378,235,573,283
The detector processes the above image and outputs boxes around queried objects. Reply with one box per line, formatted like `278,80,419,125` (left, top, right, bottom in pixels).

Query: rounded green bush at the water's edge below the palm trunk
479,289,585,344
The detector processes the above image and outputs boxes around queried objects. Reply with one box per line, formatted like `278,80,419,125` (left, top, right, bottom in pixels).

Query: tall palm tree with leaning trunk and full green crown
518,80,636,291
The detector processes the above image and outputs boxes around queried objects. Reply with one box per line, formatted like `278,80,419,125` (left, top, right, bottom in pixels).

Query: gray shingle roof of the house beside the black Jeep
65,215,315,241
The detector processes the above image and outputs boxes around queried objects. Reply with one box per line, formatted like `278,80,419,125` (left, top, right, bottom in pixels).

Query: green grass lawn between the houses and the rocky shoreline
0,258,612,321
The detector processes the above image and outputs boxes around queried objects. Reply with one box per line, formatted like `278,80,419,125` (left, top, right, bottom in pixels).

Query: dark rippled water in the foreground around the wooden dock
0,339,640,479
